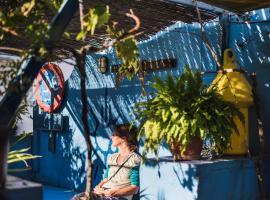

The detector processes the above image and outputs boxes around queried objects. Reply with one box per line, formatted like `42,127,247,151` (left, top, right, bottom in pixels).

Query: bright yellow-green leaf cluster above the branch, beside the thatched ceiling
76,4,111,40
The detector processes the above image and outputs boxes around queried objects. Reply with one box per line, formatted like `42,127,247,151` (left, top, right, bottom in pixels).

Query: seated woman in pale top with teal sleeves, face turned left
74,124,141,200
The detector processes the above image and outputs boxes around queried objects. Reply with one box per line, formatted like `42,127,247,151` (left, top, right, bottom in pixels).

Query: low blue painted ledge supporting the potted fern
140,158,259,200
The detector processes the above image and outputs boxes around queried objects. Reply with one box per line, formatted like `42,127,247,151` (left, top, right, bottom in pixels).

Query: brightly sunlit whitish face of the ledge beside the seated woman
140,157,198,200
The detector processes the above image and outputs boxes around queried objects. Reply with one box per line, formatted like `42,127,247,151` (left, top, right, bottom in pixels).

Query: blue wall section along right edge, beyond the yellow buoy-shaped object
230,8,270,199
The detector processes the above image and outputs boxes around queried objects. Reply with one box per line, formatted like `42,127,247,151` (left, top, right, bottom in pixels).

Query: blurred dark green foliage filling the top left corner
0,0,62,56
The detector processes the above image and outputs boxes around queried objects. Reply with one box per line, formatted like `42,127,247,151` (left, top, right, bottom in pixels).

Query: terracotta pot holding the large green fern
170,136,203,160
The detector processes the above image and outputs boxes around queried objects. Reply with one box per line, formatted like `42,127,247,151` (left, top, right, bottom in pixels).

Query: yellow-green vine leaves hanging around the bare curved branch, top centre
76,4,139,79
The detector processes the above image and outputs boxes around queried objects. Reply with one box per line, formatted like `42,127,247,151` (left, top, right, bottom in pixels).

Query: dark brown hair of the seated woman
114,124,139,151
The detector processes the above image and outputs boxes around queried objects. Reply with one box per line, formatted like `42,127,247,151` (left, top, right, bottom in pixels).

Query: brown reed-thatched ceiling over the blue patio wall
1,0,217,55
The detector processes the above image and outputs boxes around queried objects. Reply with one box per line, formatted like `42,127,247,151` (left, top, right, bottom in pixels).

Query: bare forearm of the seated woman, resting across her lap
103,185,139,197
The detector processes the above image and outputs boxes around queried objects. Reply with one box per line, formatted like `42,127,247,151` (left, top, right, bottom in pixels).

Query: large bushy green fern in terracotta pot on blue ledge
135,66,244,160
